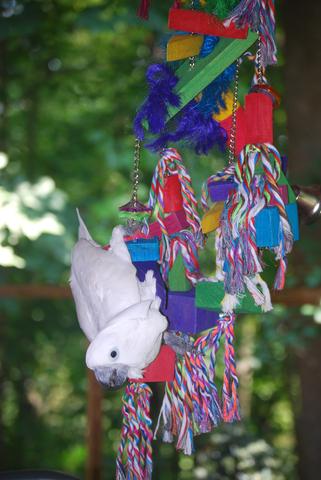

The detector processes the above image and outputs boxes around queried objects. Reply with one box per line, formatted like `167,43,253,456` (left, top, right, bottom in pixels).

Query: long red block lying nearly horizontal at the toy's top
168,8,248,39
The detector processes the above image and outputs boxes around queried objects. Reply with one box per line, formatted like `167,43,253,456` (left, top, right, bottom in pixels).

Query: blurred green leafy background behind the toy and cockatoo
0,0,321,480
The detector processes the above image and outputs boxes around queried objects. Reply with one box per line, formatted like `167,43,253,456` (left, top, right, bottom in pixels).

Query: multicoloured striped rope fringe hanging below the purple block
155,315,240,454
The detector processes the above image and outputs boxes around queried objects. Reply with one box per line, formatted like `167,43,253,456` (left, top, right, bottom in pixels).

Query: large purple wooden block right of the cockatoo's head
167,288,219,334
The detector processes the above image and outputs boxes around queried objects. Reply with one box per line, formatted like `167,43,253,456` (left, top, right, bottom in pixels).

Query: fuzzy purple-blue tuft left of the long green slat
134,64,180,140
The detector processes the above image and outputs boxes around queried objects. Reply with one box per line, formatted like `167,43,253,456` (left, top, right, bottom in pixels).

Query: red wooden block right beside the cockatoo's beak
129,345,176,383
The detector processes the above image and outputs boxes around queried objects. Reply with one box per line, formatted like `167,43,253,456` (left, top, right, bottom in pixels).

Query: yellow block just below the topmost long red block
166,35,203,62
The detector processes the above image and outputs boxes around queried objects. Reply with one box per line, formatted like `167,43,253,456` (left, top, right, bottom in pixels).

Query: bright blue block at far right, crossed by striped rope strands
255,203,299,248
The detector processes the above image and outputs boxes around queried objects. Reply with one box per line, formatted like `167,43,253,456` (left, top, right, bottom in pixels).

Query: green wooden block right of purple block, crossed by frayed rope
195,282,262,313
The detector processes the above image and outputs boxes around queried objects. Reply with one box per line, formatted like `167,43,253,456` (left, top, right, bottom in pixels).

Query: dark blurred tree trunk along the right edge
282,0,321,480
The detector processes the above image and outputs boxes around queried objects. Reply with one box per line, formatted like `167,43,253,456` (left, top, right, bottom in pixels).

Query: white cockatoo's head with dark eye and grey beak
86,298,167,388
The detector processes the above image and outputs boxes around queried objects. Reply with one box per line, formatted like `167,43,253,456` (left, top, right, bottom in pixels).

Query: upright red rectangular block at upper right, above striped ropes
245,93,273,144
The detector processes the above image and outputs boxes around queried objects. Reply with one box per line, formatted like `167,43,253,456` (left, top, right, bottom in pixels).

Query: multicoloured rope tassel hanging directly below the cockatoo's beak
116,383,153,480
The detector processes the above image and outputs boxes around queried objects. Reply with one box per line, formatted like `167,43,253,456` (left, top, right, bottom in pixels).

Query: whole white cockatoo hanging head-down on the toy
70,213,167,388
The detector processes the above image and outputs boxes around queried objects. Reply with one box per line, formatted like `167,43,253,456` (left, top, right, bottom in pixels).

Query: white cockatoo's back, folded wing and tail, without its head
71,214,141,332
